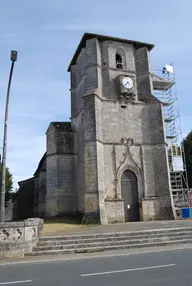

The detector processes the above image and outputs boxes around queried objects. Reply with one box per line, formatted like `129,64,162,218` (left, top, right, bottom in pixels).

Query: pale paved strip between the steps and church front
42,220,192,236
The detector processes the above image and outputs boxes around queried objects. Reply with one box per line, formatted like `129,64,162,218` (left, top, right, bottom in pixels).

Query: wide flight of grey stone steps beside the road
25,227,192,256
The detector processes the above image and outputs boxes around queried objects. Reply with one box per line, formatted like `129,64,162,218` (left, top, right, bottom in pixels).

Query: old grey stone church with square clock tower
17,33,173,224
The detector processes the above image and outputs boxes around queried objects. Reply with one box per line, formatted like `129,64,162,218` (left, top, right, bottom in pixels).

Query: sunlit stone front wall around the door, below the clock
102,98,171,218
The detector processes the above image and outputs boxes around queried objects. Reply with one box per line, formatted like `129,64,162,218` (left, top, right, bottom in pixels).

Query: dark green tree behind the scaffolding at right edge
183,131,192,188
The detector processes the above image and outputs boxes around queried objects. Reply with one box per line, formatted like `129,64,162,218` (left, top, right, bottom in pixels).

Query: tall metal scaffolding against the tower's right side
151,64,189,218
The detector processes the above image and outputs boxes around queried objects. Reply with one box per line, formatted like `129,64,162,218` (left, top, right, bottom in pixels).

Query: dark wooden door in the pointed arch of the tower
121,170,140,221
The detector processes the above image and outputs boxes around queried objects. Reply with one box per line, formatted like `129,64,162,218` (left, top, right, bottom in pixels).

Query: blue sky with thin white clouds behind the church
0,0,192,187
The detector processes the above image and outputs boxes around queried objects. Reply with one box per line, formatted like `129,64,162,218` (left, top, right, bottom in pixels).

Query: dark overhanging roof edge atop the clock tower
67,33,154,71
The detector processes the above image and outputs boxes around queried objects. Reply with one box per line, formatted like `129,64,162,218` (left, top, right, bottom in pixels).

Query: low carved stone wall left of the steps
0,218,43,259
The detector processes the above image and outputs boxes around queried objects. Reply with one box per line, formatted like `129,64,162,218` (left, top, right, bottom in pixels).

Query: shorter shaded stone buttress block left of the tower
46,122,78,216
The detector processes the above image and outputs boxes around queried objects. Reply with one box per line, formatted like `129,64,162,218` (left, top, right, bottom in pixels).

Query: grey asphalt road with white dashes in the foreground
0,249,192,286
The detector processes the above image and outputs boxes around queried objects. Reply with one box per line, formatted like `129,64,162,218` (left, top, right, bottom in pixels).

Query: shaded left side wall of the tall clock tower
71,39,103,212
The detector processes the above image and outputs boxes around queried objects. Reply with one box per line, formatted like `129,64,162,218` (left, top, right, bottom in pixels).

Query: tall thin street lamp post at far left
0,51,17,223
